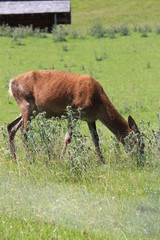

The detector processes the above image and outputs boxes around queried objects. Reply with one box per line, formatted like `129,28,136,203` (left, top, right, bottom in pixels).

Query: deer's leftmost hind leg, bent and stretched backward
7,115,22,162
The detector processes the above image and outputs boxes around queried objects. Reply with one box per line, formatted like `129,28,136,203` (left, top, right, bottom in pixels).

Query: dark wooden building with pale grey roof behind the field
0,0,71,30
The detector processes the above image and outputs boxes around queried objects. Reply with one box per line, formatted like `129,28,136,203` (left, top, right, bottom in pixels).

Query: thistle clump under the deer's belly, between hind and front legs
13,107,91,176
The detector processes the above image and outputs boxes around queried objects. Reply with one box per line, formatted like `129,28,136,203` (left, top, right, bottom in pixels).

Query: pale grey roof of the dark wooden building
0,0,70,15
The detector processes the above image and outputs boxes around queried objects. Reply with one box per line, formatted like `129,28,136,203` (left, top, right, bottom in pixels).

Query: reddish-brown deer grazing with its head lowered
7,70,144,163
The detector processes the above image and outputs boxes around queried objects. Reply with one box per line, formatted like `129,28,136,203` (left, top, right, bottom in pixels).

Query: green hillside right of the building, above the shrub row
71,0,160,29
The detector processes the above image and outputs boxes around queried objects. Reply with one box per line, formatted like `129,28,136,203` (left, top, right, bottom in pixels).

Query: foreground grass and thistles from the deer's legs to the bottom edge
0,109,160,239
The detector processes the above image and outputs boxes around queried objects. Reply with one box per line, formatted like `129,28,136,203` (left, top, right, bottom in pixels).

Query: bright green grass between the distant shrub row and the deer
0,32,160,124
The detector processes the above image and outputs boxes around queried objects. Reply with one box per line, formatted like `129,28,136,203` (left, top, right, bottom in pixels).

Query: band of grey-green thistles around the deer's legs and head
0,108,160,176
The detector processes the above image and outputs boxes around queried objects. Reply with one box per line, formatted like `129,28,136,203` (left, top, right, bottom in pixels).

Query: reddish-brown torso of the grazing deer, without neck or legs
12,70,104,118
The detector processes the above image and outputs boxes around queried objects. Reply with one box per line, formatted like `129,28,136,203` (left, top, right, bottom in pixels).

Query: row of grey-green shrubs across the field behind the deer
0,21,159,45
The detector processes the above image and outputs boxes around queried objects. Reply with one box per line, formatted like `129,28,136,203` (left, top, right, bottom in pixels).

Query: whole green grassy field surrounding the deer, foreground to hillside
0,1,160,240
